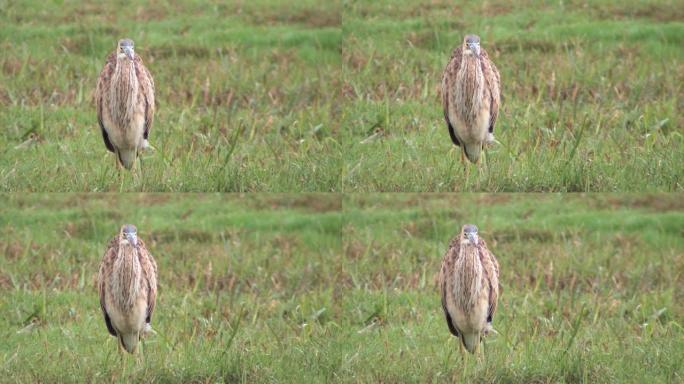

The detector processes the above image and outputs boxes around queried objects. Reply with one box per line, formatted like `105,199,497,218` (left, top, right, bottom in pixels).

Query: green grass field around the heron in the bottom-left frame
0,194,342,383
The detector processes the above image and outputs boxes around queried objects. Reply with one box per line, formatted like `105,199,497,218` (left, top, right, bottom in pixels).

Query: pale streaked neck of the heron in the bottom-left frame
113,244,141,308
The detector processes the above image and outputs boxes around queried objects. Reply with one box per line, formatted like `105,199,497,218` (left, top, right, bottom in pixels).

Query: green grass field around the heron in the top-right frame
341,0,684,192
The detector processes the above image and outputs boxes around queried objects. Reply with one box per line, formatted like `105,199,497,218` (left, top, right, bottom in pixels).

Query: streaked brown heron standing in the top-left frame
95,39,155,170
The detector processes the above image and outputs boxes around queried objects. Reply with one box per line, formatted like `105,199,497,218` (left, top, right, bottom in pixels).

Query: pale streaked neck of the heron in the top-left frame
109,58,138,126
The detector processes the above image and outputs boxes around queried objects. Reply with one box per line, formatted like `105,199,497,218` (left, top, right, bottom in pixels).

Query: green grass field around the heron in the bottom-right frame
340,194,684,383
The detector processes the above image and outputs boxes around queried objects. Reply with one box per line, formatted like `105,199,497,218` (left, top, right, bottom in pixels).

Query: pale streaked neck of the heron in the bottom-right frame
454,245,482,310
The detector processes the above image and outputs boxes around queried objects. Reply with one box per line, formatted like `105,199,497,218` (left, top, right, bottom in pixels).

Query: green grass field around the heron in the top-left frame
0,0,342,192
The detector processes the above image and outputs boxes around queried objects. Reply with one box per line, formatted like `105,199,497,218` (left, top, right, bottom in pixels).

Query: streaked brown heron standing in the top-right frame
441,35,501,163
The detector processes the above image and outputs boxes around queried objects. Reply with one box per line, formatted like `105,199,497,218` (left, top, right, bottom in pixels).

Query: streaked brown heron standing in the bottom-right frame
439,224,500,354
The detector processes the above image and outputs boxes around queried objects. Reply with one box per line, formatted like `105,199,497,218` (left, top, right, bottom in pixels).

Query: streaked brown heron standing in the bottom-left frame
98,224,157,354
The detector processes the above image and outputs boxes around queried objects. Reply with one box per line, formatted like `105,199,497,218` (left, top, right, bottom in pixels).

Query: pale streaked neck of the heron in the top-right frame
456,53,484,118
